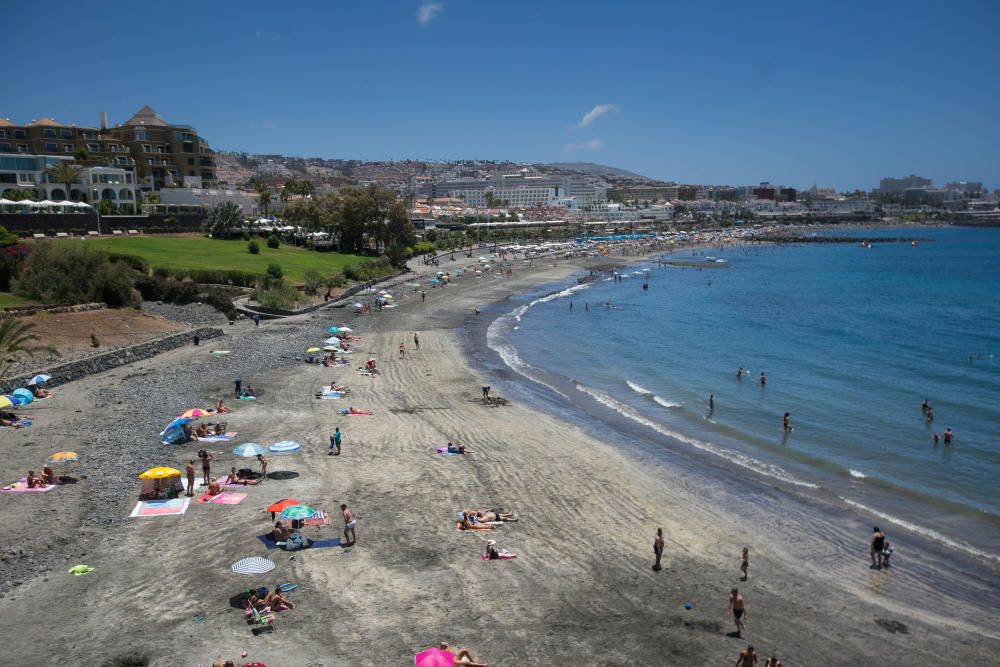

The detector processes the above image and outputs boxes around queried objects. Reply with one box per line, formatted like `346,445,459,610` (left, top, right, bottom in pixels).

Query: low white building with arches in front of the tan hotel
0,153,136,205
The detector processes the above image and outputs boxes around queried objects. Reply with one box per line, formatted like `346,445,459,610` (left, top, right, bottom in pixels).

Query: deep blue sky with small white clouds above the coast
0,0,1000,190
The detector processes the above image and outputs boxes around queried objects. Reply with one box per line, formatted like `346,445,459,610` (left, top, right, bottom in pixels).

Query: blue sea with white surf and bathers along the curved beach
490,228,1000,560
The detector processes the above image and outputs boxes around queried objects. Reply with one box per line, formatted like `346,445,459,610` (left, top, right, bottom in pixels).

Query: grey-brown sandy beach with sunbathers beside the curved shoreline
0,252,1000,667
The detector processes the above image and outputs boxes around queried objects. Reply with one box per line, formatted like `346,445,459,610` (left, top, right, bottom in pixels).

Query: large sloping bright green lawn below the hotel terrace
47,234,370,282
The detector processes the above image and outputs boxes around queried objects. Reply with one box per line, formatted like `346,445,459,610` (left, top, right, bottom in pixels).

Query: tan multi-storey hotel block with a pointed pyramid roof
101,106,217,190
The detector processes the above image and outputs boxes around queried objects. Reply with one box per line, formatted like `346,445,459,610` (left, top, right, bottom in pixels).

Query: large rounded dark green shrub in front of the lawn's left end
14,244,139,308
